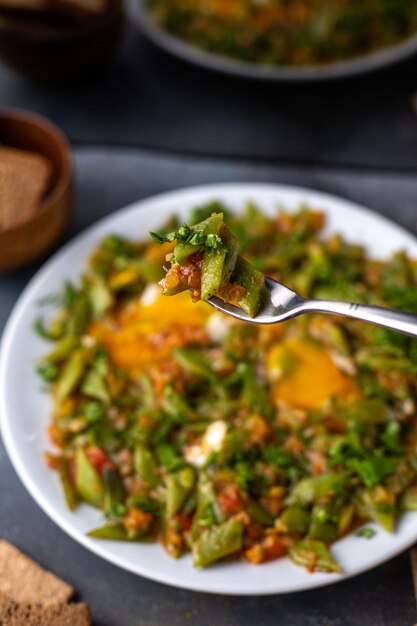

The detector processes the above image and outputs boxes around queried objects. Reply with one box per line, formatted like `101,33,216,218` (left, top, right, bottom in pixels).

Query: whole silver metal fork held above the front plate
207,276,417,337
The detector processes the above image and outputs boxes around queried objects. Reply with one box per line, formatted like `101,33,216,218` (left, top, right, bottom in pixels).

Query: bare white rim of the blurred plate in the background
127,0,417,82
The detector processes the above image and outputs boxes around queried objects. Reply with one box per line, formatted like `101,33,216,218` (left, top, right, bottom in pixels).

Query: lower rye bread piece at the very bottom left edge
0,592,91,626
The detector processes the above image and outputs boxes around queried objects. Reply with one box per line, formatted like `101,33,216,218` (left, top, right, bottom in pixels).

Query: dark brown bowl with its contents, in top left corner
0,0,123,81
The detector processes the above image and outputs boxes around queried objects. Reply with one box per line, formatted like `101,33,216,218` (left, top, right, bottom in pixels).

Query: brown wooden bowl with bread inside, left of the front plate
0,111,73,271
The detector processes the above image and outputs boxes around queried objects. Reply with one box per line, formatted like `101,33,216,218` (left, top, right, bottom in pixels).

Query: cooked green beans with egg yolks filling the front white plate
36,203,417,572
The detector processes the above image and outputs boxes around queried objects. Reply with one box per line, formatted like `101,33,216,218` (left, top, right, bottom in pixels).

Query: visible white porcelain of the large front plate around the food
0,184,417,595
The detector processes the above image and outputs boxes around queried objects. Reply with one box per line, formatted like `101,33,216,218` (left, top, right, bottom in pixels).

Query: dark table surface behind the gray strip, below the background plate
0,21,417,170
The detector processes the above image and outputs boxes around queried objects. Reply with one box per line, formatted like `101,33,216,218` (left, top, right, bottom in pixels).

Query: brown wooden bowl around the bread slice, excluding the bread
0,111,73,272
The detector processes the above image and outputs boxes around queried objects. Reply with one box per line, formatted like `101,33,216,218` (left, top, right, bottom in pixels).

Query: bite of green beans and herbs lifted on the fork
151,213,264,317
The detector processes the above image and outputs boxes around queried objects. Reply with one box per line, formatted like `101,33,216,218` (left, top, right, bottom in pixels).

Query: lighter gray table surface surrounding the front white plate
0,148,417,626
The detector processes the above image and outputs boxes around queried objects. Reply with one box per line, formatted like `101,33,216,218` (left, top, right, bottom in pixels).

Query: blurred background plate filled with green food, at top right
128,0,417,81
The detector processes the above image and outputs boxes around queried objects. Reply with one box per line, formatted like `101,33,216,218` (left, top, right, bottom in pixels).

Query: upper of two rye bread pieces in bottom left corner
0,541,73,608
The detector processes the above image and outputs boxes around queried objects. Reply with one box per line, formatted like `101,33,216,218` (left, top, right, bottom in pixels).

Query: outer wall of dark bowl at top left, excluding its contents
0,0,123,81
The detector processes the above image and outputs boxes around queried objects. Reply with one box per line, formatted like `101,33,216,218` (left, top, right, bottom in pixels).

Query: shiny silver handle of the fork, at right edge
303,300,417,337
